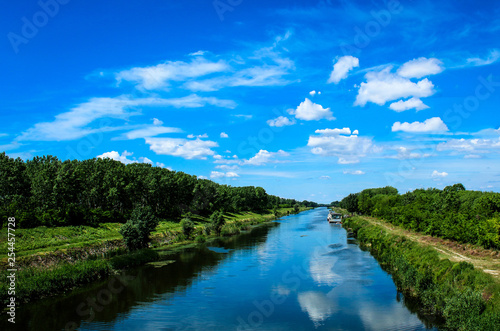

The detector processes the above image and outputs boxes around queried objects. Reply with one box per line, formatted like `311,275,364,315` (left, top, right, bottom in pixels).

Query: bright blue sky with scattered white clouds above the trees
0,0,500,202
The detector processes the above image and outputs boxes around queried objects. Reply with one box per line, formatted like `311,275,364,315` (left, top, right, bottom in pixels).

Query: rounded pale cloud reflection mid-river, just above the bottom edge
298,291,335,326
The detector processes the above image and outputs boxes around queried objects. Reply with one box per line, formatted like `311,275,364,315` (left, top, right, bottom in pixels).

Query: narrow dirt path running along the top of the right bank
361,216,500,280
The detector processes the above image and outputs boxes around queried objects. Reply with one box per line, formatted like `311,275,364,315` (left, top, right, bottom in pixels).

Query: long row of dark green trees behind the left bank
0,152,317,228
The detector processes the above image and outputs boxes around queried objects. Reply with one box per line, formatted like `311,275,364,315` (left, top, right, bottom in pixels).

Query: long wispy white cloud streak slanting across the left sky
18,94,236,141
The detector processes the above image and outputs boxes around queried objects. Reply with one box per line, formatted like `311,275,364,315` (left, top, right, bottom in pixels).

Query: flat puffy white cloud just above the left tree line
146,138,219,160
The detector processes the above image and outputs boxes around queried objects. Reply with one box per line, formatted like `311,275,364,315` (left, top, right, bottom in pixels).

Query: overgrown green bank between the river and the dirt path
343,217,500,330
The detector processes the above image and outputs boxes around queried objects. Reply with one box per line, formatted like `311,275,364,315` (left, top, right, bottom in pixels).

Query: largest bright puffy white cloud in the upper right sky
354,66,435,106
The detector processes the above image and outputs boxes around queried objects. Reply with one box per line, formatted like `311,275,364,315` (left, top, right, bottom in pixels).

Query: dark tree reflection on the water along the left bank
10,223,279,331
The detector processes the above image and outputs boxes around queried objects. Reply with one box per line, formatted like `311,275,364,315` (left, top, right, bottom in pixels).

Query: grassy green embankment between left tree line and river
0,207,310,302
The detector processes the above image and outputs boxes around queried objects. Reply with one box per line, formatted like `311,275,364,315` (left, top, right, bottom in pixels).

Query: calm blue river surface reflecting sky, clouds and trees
7,208,436,331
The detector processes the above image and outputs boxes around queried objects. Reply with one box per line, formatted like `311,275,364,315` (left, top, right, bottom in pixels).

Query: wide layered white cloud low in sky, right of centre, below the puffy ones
307,128,374,164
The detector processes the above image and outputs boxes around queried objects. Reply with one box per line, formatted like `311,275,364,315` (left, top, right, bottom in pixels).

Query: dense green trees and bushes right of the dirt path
341,184,500,249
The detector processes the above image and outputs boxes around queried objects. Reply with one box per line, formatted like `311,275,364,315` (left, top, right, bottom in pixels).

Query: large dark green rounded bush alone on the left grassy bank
119,206,158,251
